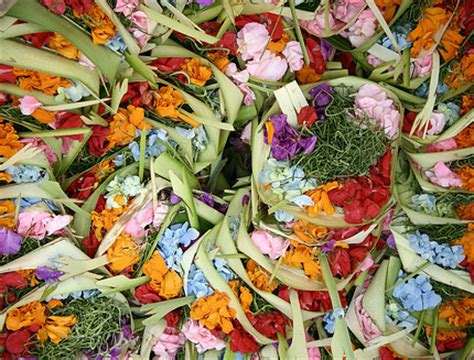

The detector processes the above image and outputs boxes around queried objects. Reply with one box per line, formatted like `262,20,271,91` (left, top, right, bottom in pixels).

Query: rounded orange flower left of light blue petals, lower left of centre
107,233,140,273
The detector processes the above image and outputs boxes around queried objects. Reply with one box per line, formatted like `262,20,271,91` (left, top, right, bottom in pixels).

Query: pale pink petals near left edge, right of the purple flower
17,211,72,240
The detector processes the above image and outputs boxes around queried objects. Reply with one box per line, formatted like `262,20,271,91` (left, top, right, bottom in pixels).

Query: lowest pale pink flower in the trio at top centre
247,50,288,81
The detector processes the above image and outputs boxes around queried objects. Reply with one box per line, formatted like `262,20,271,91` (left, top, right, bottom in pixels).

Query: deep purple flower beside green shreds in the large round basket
264,114,317,160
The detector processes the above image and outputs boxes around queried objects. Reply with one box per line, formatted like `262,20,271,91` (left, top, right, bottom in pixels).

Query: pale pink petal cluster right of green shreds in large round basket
354,84,400,140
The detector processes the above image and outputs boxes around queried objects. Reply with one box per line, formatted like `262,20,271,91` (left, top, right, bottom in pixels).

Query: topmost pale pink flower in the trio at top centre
237,22,270,60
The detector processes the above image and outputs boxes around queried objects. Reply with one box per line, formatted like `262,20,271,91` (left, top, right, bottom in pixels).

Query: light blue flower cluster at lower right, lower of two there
393,275,441,311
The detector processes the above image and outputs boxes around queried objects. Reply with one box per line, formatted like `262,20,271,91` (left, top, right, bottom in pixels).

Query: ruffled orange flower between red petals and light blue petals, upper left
107,105,151,149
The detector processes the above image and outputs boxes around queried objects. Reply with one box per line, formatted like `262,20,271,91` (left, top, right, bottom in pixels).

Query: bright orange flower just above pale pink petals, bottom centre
191,291,236,334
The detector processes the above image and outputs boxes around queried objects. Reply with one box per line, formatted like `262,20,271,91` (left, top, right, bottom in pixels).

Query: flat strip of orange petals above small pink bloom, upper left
13,67,71,95
